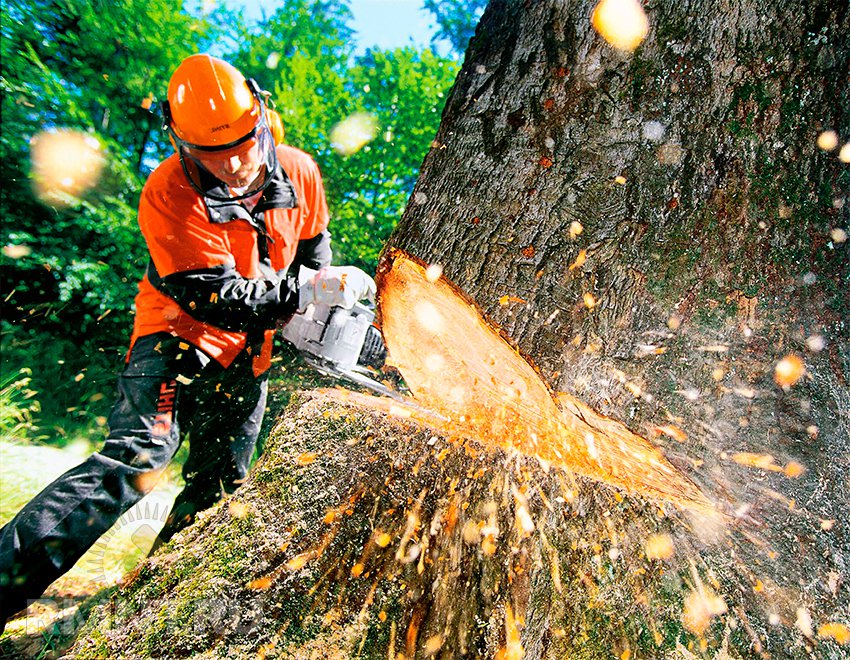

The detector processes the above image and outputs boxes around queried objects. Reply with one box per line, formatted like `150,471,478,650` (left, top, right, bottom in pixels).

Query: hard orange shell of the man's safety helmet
168,54,262,147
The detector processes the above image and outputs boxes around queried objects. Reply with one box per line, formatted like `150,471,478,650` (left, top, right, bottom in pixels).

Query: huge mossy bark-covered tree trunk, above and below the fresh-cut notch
63,0,850,658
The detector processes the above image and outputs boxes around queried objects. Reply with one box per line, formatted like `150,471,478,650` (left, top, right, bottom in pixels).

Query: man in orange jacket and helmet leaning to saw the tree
0,55,375,622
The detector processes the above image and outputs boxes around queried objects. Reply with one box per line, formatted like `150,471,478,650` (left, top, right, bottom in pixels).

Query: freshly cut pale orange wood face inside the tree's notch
377,250,715,513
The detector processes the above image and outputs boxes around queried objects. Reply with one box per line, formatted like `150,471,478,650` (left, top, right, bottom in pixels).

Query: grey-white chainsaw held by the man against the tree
276,303,402,400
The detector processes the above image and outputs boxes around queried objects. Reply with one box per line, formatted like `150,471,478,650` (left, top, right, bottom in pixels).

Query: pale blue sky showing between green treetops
234,0,433,52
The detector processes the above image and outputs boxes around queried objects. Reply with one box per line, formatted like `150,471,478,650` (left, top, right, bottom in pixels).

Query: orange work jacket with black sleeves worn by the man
130,145,331,375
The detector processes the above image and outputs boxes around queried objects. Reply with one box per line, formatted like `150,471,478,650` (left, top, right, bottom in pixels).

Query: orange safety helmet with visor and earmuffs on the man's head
162,54,277,200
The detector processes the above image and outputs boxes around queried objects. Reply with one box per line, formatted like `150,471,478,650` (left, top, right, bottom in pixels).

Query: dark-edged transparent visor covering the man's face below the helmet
175,113,277,201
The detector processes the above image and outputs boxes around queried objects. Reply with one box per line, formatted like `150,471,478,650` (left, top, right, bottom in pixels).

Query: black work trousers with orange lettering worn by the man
0,333,267,620
